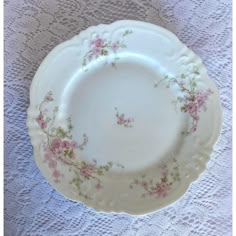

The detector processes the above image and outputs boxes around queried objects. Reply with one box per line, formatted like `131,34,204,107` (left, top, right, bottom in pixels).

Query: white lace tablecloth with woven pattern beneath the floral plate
4,0,232,236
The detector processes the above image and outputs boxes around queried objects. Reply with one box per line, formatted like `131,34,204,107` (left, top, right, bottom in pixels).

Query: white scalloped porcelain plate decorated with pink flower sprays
27,21,222,214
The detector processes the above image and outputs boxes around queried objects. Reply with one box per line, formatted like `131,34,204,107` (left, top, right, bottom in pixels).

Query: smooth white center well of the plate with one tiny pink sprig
64,57,185,171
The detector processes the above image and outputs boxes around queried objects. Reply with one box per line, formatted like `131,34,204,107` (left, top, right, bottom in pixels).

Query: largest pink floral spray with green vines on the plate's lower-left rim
35,92,124,199
